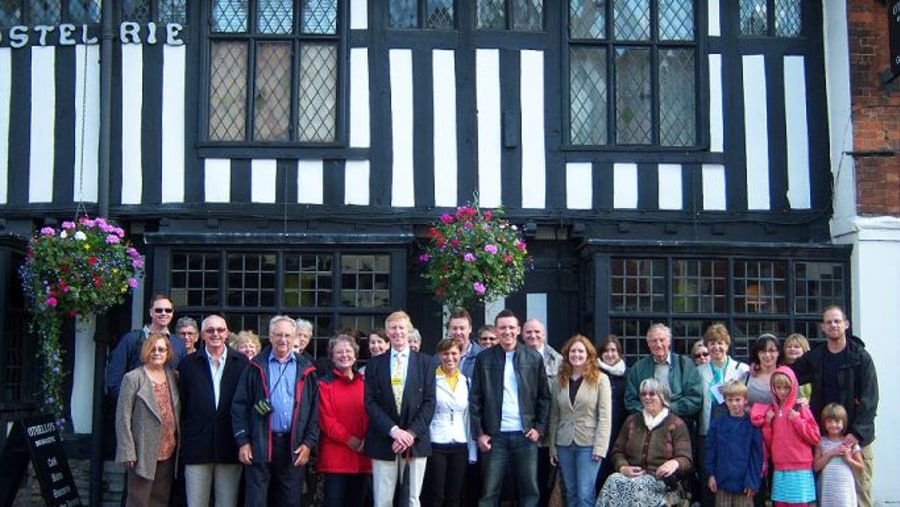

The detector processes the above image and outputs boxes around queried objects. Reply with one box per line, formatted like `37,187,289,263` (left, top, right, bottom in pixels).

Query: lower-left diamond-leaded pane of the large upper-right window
569,47,607,145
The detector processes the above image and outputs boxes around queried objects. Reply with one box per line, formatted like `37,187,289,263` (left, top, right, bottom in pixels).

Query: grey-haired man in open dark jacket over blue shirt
231,315,319,507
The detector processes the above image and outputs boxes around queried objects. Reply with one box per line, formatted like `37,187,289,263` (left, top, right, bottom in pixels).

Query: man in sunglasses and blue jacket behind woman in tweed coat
106,294,187,402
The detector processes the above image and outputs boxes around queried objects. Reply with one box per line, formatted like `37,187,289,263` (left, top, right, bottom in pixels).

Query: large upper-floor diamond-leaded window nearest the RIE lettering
207,0,342,143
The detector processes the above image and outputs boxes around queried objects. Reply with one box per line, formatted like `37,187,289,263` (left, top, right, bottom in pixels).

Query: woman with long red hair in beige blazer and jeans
550,335,612,507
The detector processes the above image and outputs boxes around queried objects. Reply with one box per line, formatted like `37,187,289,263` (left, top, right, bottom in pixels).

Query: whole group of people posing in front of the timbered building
107,296,878,507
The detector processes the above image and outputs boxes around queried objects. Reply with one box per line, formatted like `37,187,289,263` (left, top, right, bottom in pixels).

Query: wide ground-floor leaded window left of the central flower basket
169,249,399,357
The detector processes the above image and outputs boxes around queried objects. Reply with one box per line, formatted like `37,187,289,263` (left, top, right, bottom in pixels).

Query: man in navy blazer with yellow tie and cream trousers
364,311,435,507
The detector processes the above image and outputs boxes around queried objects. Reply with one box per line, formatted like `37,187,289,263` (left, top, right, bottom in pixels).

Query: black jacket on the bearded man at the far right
790,336,878,447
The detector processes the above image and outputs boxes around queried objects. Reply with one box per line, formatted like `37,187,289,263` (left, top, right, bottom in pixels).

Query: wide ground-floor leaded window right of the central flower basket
608,256,849,368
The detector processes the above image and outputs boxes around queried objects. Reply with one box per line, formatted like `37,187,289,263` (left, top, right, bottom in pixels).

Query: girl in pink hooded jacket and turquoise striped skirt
751,366,820,507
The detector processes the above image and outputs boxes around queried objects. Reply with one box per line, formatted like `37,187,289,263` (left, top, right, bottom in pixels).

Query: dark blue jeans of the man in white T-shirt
478,431,540,507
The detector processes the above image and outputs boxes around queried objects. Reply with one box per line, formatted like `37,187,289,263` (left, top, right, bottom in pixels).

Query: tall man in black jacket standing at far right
791,306,878,507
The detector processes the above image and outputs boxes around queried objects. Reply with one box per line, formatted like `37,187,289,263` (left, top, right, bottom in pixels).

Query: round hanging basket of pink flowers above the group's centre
419,200,529,308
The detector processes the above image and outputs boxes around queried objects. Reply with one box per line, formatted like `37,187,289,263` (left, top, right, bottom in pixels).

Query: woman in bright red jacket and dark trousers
316,334,372,507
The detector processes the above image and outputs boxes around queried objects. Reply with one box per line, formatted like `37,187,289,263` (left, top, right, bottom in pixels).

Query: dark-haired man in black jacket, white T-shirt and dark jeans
469,310,550,507
